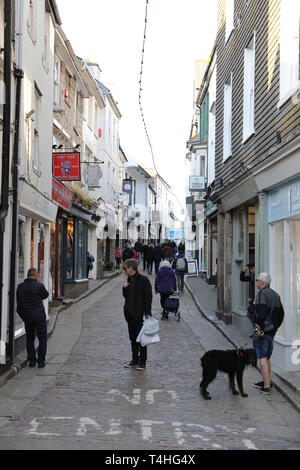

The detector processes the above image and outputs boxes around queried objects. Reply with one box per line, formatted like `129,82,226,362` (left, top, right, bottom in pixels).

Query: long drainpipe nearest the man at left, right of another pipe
7,0,24,365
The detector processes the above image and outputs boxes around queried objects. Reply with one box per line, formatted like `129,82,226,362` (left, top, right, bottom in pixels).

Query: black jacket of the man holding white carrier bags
123,272,152,321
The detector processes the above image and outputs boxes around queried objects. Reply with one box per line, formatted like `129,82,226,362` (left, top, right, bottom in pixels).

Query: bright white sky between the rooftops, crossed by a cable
57,0,217,204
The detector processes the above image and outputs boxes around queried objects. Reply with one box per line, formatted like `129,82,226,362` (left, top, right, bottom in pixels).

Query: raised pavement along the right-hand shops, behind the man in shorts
185,277,300,412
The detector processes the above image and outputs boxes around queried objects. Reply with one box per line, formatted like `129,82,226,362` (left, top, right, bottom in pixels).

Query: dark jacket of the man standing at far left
17,279,49,323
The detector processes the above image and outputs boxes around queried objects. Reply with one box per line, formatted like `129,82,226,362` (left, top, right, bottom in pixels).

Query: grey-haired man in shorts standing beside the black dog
248,273,284,395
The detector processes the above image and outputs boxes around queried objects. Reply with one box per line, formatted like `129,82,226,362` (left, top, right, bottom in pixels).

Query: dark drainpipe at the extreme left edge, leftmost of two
0,0,12,352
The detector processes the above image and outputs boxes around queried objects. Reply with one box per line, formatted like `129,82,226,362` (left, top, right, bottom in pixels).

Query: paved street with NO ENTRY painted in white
0,278,300,450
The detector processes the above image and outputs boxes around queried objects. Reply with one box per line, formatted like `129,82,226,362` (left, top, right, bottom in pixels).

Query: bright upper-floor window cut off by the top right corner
280,0,300,101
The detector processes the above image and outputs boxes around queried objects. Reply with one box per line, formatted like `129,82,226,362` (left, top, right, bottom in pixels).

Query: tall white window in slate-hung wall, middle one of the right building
243,34,255,141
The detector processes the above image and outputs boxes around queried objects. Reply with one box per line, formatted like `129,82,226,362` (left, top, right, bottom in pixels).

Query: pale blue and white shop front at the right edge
268,177,300,371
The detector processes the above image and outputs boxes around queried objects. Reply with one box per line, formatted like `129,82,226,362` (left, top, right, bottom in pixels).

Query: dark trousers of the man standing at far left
25,320,47,364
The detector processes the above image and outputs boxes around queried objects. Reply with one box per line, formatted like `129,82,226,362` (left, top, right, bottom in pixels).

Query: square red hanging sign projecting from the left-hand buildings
53,152,81,181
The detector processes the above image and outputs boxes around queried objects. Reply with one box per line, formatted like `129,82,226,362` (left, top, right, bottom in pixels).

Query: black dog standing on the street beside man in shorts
200,349,257,400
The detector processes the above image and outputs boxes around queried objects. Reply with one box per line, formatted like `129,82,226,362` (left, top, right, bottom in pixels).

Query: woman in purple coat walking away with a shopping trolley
155,260,177,319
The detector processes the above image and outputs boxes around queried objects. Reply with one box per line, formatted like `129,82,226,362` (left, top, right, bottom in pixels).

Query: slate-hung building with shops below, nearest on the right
209,0,300,370
